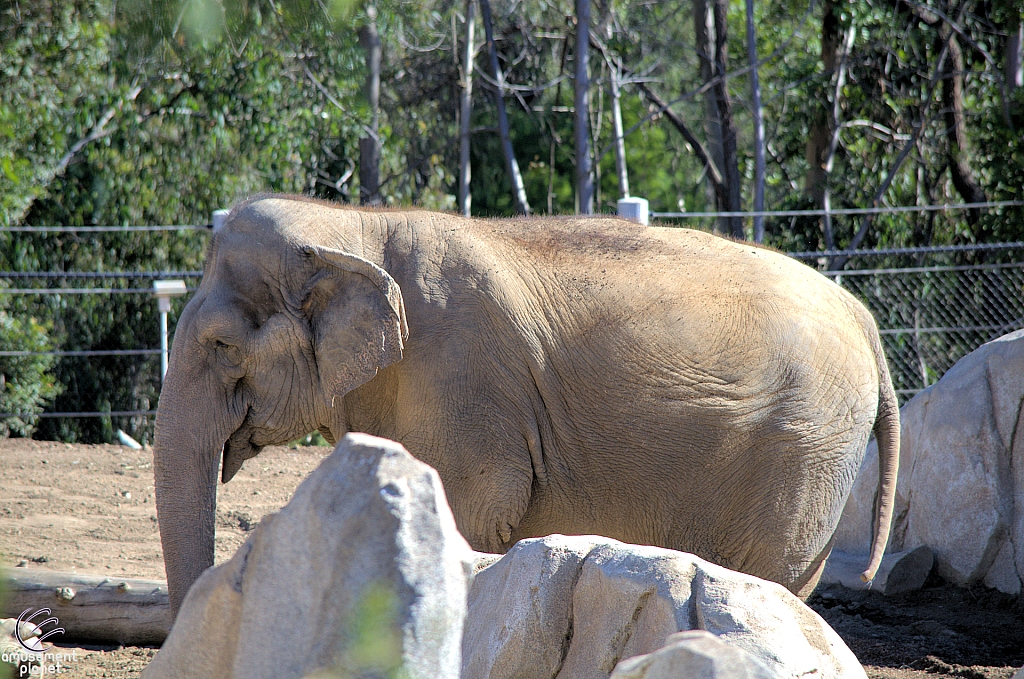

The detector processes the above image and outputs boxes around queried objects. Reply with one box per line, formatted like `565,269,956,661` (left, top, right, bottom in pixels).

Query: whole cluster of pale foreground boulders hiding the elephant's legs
142,434,864,679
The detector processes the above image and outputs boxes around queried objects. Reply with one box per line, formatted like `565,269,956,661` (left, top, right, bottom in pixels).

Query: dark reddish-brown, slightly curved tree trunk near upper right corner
939,23,985,224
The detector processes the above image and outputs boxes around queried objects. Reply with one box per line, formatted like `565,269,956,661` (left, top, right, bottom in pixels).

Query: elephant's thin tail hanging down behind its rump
860,329,899,583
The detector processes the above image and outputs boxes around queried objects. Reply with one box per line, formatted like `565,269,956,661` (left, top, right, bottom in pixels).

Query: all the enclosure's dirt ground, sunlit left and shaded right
0,439,1024,679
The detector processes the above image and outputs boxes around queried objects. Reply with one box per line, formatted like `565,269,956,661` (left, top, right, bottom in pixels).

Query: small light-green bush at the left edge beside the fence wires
0,309,61,437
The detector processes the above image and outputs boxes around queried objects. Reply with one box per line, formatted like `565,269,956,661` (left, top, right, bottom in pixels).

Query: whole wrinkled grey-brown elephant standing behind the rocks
154,195,899,611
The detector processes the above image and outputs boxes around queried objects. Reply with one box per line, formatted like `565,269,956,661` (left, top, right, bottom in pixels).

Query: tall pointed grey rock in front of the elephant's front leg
142,434,473,679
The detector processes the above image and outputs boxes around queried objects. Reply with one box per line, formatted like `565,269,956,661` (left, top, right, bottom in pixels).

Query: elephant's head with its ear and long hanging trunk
154,202,408,614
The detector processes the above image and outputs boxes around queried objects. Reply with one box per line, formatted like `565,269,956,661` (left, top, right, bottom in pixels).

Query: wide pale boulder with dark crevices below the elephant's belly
463,536,864,679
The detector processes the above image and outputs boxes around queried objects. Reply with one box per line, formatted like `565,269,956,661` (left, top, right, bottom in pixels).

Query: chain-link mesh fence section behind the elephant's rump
794,243,1024,404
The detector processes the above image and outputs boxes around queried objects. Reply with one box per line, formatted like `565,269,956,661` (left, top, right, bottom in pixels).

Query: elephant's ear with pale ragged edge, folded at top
302,247,409,408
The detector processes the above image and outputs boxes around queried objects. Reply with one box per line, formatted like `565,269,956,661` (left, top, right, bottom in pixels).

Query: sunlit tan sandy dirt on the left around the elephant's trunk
0,438,331,679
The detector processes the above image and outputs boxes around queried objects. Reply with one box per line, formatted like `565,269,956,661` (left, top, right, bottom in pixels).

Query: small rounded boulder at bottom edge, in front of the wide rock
611,630,777,679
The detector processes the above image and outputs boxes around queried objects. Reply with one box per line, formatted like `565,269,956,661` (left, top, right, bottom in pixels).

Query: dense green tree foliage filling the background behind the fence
0,0,1024,441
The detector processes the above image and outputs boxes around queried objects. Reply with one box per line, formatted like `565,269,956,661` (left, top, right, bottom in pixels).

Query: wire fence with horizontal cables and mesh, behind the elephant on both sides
0,202,1024,419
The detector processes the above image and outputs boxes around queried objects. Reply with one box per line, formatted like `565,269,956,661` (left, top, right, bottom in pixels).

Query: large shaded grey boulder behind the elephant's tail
836,331,1024,594
